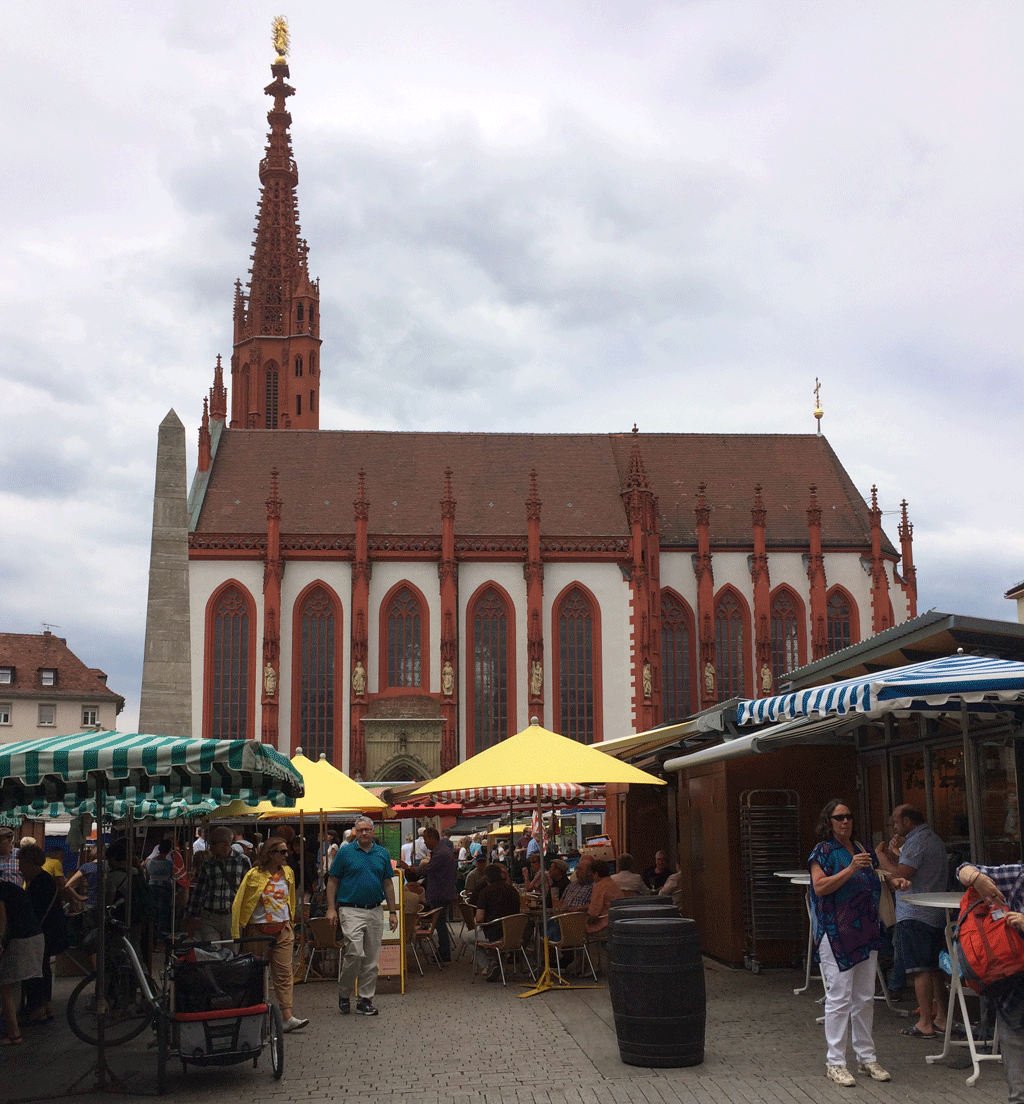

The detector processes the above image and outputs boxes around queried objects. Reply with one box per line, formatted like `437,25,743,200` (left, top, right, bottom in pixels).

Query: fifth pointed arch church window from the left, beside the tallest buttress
555,586,600,744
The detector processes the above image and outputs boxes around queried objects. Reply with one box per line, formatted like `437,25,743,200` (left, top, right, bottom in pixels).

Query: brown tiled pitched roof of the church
196,429,896,554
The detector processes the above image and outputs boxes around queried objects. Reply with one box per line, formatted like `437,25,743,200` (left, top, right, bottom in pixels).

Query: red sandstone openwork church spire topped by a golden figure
231,18,320,429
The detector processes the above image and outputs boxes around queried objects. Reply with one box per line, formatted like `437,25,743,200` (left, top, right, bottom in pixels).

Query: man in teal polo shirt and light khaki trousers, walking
327,817,398,1016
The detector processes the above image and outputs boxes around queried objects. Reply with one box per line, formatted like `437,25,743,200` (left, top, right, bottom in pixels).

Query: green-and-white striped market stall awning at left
0,732,302,819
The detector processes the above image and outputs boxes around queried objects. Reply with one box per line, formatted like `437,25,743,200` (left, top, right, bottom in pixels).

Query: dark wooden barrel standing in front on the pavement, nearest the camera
608,916,707,1069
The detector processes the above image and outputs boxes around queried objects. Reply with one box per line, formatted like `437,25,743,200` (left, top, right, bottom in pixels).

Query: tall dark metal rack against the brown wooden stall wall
739,789,803,974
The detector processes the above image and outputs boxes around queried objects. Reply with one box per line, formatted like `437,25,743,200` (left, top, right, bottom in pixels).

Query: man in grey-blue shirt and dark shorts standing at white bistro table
875,805,949,1039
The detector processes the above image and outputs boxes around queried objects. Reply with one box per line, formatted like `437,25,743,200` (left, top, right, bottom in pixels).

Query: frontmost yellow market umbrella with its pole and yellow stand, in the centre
409,720,665,997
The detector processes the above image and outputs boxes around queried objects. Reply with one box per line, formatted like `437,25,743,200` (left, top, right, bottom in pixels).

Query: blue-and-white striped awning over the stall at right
736,656,1024,724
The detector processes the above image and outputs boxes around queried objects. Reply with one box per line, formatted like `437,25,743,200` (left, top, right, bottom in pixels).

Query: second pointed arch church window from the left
298,586,337,763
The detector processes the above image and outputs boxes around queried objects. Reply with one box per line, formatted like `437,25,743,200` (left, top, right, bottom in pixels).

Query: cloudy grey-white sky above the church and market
0,0,1024,729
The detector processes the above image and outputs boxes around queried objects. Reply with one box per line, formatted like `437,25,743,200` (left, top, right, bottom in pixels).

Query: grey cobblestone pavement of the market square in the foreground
0,955,1006,1104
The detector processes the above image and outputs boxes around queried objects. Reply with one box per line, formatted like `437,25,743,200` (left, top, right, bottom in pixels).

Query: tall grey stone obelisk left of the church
139,411,193,736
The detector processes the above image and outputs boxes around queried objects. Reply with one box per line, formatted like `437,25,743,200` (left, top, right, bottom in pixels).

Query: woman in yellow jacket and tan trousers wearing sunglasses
231,836,309,1031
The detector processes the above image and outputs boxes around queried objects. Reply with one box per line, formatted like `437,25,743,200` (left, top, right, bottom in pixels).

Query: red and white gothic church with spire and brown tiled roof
177,47,917,781
